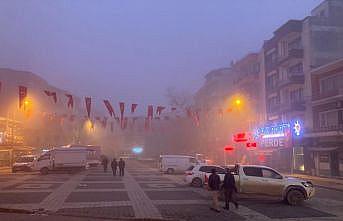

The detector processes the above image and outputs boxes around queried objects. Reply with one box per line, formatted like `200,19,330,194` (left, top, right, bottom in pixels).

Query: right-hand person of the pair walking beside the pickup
222,169,238,210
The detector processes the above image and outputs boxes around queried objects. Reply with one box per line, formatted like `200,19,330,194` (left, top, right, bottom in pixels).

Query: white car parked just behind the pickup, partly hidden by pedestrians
185,164,225,187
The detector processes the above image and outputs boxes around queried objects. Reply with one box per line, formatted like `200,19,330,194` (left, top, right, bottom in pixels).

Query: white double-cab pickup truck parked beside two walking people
187,165,315,205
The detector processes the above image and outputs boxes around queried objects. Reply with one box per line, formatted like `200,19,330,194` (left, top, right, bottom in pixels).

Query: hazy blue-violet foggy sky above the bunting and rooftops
0,0,321,104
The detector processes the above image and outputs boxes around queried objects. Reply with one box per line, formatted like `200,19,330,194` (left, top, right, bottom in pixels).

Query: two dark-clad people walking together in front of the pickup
208,169,238,212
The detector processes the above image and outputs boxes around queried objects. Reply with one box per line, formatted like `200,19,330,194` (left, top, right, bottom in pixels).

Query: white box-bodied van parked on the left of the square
34,147,88,174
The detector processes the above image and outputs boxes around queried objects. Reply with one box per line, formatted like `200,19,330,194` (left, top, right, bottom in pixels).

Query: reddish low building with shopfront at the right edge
305,59,343,176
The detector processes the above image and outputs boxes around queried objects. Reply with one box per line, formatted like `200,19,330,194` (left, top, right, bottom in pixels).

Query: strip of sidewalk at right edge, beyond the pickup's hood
288,174,343,191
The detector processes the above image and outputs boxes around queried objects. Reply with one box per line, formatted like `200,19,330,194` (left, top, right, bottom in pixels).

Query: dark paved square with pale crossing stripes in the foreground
0,161,343,221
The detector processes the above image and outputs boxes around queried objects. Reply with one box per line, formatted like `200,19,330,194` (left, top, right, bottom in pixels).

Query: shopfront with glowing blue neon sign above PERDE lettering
255,120,305,173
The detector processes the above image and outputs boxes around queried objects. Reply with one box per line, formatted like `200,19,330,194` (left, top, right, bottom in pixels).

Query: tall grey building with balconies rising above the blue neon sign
261,0,343,172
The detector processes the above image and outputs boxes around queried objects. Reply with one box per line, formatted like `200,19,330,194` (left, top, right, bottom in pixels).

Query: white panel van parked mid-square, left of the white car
159,155,197,174
